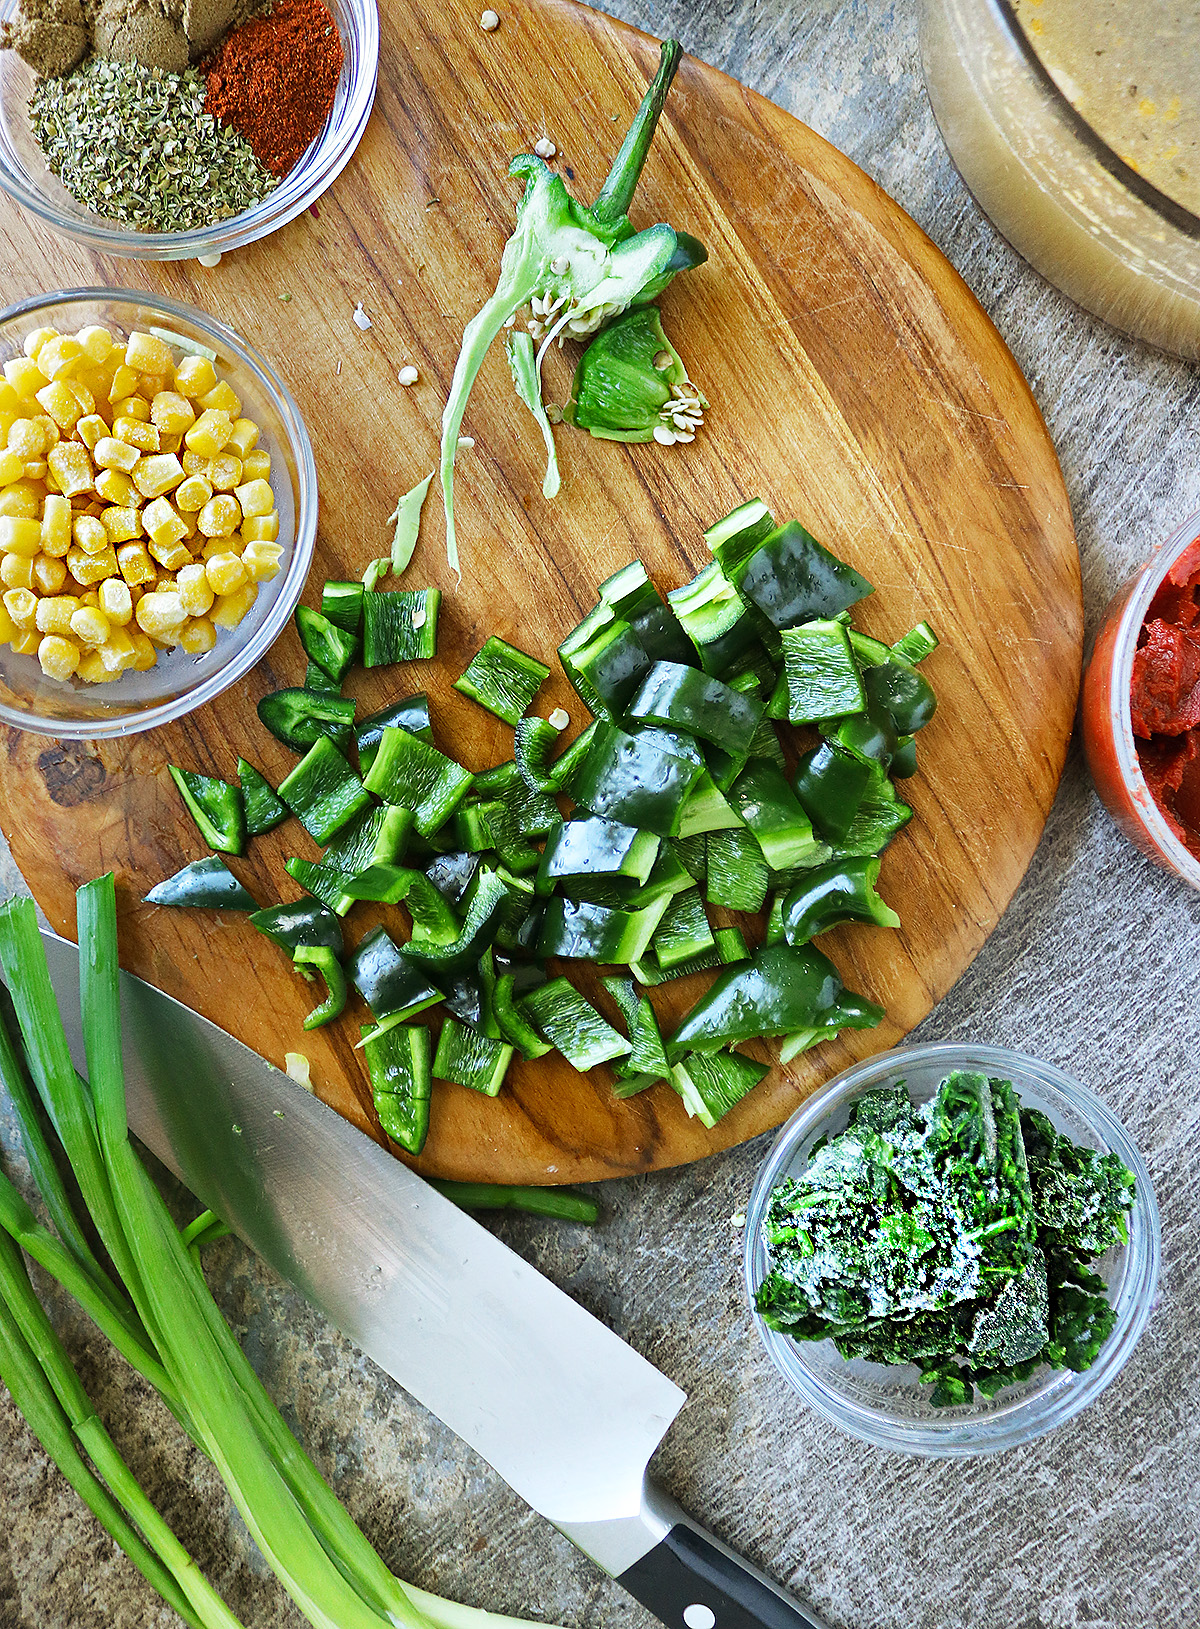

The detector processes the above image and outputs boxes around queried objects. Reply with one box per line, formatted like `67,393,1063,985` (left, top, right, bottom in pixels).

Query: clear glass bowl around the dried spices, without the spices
0,0,379,261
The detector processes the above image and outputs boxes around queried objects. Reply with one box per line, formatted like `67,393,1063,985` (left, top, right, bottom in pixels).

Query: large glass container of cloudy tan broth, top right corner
920,0,1200,357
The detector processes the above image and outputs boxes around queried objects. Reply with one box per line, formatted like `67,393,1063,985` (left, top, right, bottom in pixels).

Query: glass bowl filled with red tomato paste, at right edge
1081,515,1200,889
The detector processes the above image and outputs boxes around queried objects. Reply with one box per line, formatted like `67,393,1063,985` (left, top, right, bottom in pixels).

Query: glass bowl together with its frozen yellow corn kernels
0,288,318,740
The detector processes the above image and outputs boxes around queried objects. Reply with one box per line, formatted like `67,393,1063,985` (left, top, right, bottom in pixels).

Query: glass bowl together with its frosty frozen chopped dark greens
746,1044,1159,1456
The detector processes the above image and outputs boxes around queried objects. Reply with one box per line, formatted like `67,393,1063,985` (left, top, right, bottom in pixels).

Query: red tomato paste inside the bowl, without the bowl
1130,538,1200,855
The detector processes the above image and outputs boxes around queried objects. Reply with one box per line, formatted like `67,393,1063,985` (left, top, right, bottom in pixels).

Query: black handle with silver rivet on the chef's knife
617,1512,824,1629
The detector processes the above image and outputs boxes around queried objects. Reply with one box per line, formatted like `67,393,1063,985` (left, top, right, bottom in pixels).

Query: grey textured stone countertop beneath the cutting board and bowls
0,0,1200,1629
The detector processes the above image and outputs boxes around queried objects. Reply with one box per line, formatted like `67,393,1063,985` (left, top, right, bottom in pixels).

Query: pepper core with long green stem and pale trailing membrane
441,39,707,570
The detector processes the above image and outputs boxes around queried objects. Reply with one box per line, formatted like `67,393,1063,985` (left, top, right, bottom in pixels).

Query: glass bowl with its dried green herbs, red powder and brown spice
0,0,379,262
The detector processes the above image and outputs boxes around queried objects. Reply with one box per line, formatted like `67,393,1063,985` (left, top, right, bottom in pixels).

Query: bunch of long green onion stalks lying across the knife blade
0,875,560,1629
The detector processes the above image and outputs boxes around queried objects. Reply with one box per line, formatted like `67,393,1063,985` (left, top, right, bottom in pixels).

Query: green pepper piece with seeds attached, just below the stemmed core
563,306,708,446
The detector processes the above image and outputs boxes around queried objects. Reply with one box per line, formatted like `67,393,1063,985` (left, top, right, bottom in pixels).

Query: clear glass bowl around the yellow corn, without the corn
0,288,318,741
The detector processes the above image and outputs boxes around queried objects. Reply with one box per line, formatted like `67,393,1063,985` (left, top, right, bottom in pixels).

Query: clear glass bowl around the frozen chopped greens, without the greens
746,1044,1159,1458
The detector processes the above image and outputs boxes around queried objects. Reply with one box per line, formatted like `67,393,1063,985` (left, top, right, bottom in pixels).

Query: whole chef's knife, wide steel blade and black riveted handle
42,932,821,1629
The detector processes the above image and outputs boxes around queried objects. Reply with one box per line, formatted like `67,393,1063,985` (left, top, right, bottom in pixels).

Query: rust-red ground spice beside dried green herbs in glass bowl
204,0,344,178
